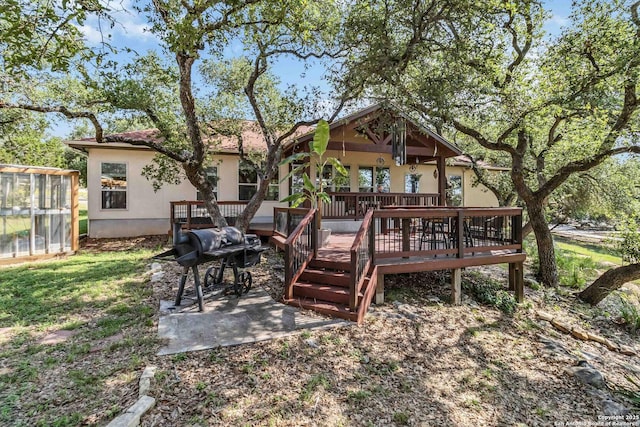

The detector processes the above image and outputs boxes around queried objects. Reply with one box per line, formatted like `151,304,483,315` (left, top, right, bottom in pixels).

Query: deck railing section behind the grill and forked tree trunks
171,200,249,229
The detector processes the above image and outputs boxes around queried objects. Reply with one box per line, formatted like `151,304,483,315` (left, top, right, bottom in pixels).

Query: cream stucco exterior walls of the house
87,148,498,238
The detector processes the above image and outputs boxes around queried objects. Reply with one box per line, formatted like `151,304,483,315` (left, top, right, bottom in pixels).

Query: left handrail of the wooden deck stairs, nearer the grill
284,209,318,299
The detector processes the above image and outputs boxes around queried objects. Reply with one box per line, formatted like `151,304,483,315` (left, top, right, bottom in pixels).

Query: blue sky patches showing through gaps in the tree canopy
51,0,571,138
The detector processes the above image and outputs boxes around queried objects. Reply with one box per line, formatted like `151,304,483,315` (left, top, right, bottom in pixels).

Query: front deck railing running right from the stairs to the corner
373,206,522,264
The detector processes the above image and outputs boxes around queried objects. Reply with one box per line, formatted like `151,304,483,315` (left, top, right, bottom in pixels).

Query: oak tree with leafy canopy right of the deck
340,0,640,286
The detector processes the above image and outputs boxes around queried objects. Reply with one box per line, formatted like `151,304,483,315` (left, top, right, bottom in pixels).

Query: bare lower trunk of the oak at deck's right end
527,198,559,287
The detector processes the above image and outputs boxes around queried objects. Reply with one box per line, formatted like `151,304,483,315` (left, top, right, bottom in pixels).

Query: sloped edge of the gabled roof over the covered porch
283,102,462,157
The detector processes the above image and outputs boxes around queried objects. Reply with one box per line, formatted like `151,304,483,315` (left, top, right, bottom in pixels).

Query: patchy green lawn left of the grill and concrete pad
0,250,156,426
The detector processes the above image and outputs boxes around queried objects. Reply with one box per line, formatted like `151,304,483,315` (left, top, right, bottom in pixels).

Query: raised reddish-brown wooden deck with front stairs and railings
280,206,526,323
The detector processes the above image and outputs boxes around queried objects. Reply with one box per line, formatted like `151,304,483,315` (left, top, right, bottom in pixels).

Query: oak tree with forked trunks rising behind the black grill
0,0,345,229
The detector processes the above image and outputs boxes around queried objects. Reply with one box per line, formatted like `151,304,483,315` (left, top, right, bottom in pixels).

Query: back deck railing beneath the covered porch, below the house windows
322,192,439,220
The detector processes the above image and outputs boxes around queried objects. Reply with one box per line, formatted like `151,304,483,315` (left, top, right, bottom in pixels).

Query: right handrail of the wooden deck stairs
349,209,373,311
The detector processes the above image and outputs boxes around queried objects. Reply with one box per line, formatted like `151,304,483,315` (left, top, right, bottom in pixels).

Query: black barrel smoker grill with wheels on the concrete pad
154,224,266,311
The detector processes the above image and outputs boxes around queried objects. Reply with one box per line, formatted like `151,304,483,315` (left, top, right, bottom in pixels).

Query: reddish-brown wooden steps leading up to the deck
284,259,377,324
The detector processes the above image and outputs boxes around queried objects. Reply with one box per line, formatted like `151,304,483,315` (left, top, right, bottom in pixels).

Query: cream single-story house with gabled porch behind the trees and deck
66,104,505,238
